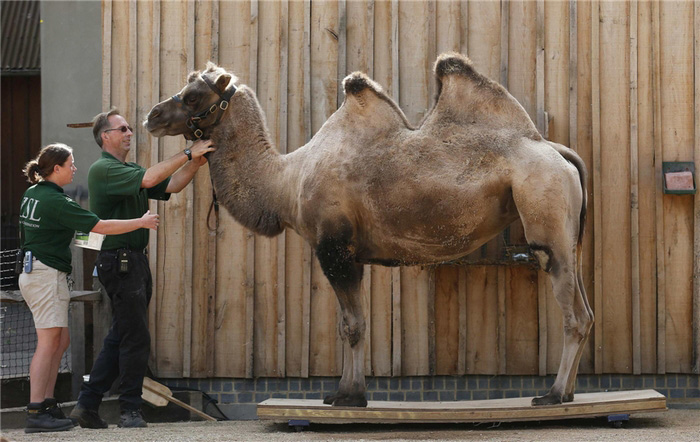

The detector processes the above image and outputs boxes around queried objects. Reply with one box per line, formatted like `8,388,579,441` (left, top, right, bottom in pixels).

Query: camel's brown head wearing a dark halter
143,62,238,140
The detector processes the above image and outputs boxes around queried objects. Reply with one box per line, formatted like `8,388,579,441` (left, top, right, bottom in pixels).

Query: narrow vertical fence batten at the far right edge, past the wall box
692,2,700,374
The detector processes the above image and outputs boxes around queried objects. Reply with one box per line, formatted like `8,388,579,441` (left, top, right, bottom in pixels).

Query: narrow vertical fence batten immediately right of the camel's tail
591,0,604,374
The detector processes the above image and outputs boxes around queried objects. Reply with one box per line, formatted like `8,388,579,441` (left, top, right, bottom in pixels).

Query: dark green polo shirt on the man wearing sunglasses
88,151,170,250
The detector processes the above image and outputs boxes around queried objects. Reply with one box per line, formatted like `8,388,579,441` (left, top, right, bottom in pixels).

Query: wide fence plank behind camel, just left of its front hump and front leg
309,2,343,376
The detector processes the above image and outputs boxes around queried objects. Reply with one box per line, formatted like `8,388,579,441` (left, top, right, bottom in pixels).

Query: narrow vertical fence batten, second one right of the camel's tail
629,0,642,374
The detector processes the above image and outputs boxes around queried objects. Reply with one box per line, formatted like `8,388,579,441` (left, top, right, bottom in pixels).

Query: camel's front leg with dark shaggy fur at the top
316,228,367,407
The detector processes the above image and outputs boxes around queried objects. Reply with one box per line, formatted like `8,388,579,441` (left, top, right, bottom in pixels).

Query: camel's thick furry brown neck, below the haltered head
210,87,292,236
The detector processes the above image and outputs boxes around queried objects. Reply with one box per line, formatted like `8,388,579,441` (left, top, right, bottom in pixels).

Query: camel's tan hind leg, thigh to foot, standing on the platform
514,175,593,405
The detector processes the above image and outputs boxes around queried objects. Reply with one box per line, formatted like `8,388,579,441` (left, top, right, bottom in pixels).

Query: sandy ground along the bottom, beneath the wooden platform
2,410,700,442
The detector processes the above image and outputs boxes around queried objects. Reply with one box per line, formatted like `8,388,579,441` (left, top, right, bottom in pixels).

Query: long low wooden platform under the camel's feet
258,390,666,423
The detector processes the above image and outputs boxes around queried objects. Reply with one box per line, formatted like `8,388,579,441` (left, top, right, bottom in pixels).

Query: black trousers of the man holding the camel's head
78,250,153,411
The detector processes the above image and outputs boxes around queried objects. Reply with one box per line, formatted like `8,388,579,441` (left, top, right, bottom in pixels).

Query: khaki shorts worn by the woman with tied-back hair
19,258,70,328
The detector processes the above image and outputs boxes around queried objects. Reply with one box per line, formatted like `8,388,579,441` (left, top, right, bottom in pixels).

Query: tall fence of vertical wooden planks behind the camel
103,0,700,377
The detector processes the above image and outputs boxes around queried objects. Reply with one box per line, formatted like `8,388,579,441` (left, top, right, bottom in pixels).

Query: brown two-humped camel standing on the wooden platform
143,53,593,407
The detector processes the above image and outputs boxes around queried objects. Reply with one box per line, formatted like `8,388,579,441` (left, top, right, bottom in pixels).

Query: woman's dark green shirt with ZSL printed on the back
19,181,100,273
